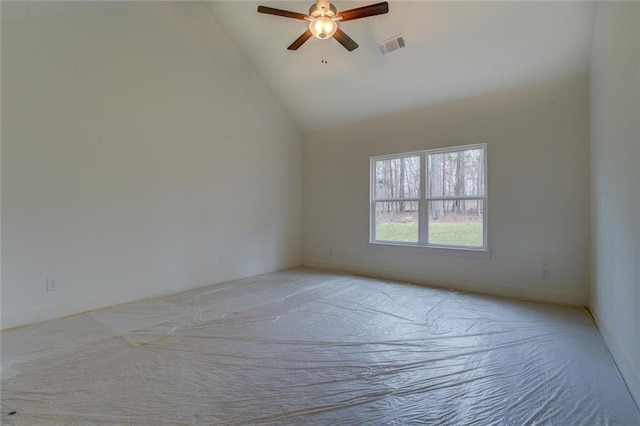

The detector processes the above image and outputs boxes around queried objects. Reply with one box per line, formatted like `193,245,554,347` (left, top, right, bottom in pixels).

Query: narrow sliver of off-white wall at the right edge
590,2,640,405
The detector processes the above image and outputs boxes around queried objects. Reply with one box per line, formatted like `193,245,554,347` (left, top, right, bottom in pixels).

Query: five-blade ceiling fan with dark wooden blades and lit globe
258,0,389,52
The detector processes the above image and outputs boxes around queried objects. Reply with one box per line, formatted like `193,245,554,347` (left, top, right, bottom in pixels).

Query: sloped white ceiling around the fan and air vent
207,0,596,132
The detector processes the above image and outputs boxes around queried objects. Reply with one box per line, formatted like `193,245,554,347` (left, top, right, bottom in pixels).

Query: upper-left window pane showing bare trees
375,156,420,200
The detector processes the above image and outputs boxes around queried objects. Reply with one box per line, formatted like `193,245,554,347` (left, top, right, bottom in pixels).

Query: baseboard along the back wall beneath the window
302,259,584,307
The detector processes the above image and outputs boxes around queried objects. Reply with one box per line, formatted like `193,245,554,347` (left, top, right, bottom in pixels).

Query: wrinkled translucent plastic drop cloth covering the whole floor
0,269,640,425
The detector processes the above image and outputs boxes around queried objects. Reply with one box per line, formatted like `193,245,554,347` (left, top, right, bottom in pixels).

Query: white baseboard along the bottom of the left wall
0,261,300,330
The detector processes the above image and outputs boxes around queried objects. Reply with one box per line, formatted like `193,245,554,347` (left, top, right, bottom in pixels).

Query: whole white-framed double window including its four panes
370,144,487,249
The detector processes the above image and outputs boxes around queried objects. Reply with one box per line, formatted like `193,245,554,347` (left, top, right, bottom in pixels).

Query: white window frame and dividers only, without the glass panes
369,143,489,252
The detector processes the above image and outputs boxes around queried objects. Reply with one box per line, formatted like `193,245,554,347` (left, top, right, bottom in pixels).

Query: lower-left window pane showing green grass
376,201,418,243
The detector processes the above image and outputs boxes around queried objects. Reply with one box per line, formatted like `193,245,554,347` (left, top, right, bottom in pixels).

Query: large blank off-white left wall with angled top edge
2,2,302,327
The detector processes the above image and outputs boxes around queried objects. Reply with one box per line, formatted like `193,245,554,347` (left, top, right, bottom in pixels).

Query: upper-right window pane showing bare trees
427,149,485,197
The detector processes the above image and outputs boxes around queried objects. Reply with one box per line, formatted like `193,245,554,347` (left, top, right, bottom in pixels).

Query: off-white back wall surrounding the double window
303,75,590,305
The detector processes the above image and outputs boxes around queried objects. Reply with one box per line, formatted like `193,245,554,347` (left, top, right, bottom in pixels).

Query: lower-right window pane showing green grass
428,200,484,247
